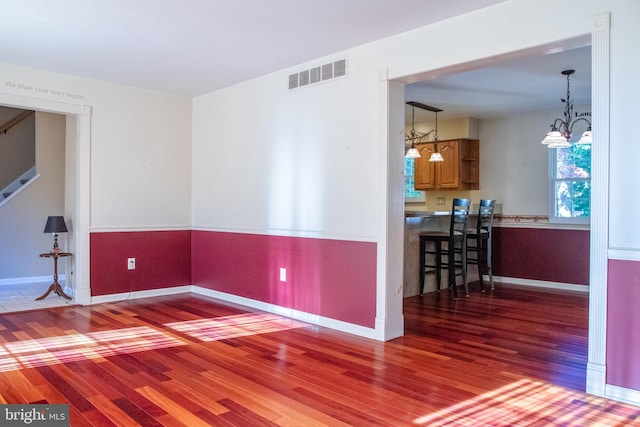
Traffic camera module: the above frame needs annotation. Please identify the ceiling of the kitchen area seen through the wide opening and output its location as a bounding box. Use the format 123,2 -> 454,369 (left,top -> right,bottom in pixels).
405,44 -> 591,121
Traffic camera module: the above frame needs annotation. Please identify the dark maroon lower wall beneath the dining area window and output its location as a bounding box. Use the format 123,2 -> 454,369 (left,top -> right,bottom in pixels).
493,227 -> 589,285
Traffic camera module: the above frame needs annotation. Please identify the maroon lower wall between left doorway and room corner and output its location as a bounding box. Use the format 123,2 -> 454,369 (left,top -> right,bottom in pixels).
90,230 -> 191,296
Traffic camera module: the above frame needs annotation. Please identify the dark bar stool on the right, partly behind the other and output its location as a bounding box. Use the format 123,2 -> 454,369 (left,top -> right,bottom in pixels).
467,199 -> 496,292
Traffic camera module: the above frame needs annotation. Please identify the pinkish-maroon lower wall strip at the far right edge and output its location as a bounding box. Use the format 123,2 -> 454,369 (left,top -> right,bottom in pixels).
607,260 -> 640,390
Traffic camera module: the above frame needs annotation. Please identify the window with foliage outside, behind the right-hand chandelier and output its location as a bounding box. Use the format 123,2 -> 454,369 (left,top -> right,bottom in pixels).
549,144 -> 591,224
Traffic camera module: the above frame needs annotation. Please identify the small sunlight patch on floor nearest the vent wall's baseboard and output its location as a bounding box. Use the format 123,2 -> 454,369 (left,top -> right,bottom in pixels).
165,313 -> 309,341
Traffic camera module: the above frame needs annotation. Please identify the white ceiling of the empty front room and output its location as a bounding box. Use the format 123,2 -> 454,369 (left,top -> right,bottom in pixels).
0,0 -> 505,96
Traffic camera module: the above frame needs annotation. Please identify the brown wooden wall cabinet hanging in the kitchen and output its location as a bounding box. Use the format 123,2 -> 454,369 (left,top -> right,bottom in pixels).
413,139 -> 480,191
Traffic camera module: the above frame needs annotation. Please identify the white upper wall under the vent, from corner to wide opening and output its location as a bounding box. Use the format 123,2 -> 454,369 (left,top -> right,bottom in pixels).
193,49 -> 379,240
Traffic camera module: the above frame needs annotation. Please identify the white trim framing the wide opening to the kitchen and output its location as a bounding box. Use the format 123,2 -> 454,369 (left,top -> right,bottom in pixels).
378,14 -> 610,396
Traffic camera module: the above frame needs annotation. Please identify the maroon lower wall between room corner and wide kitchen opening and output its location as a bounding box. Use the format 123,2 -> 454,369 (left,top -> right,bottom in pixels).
192,231 -> 377,327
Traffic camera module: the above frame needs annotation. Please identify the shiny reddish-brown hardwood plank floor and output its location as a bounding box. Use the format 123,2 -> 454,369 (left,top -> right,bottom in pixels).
0,285 -> 640,427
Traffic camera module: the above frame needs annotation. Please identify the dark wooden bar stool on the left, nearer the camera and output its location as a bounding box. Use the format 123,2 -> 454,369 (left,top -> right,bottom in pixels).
419,199 -> 471,299
